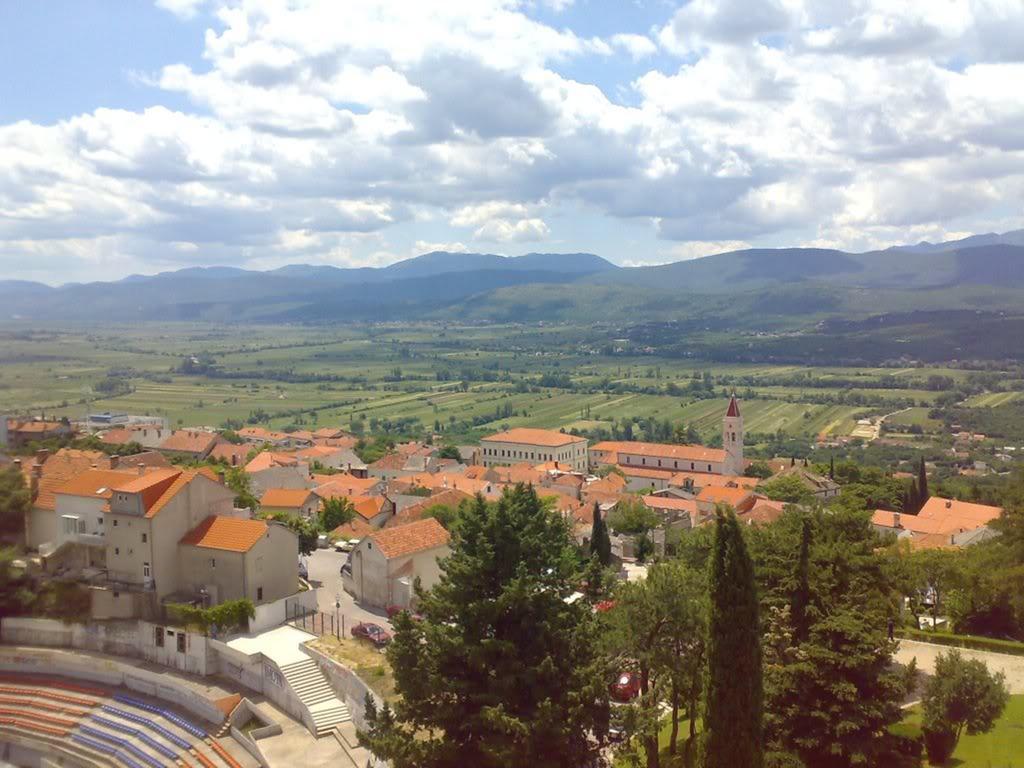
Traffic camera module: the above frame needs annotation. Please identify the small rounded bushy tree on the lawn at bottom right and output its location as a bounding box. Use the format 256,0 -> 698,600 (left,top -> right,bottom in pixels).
922,650 -> 1010,764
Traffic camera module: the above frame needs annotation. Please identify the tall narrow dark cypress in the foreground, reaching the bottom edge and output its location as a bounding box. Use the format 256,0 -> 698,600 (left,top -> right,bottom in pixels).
705,510 -> 764,768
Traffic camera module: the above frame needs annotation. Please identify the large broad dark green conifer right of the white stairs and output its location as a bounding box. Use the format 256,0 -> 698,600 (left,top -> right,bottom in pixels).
359,484 -> 607,768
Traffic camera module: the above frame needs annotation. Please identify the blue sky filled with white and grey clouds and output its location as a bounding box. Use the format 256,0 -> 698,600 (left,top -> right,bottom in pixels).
0,0 -> 1024,284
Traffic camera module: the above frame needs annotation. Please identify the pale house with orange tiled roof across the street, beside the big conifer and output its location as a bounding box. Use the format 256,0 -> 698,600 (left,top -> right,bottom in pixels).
341,517 -> 451,608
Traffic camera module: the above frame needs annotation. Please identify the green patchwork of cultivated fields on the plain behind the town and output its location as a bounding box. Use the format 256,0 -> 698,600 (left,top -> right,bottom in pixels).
0,325 -> 1018,448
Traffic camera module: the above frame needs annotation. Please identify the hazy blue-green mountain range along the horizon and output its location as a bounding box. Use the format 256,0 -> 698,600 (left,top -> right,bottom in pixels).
6,229 -> 1024,329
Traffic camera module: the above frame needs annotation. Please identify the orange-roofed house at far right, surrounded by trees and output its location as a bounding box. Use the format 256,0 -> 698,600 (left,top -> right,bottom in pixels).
871,496 -> 1002,548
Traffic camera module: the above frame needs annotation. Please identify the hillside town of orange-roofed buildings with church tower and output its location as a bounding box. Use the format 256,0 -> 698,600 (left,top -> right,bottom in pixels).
0,395 -> 1024,766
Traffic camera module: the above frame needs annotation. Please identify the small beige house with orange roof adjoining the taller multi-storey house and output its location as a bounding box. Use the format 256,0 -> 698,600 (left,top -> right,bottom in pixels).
177,515 -> 299,605
